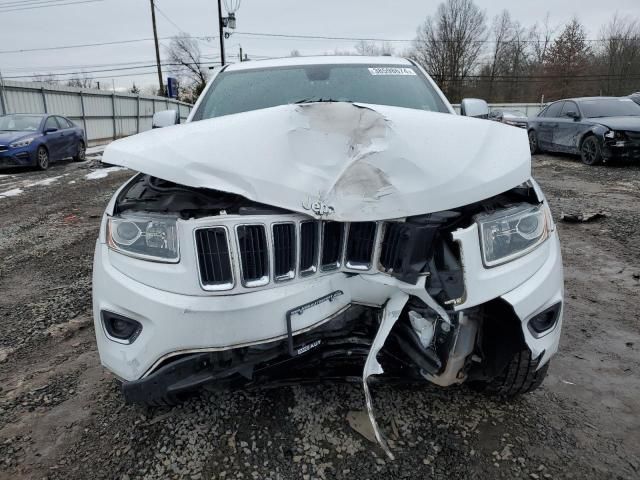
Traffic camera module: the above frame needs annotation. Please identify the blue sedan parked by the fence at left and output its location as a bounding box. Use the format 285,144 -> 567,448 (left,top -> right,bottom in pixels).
0,113 -> 87,170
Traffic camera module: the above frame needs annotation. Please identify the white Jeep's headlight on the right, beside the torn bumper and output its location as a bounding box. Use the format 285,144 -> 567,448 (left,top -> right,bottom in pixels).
476,203 -> 553,267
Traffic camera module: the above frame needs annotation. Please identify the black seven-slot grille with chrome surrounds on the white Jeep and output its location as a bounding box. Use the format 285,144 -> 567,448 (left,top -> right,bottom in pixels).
195,217 -> 382,291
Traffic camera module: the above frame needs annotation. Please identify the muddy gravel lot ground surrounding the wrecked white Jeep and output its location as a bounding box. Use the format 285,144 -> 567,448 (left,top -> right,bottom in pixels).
0,156 -> 640,479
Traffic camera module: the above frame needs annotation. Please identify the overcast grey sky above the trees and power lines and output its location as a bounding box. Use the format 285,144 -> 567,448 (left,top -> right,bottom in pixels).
0,0 -> 640,89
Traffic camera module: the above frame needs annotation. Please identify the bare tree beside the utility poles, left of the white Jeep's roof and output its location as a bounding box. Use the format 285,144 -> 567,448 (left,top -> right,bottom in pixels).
166,33 -> 207,102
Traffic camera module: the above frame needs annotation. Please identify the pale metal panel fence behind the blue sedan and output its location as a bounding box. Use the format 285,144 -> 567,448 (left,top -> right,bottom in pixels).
0,80 -> 191,145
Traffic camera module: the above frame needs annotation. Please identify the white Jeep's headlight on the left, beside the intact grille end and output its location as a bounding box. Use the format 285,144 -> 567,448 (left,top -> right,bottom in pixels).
107,215 -> 180,263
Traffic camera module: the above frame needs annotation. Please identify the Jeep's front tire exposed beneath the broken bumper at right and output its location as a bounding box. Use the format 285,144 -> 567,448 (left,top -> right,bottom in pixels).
475,349 -> 549,397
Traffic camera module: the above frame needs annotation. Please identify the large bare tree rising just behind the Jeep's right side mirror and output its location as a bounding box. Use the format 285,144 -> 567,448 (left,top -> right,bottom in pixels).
412,0 -> 487,100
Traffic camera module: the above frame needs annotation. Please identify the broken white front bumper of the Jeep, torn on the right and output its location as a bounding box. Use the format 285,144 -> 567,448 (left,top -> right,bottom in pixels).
93,229 -> 563,381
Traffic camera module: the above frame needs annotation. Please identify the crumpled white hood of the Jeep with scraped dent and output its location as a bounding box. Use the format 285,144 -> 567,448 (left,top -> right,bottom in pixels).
103,103 -> 531,221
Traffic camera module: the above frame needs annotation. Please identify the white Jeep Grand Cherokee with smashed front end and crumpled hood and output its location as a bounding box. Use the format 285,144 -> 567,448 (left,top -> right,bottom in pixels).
93,56 -> 563,458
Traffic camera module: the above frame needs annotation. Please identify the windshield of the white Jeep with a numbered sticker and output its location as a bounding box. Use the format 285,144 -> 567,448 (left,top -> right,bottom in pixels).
193,65 -> 449,120
